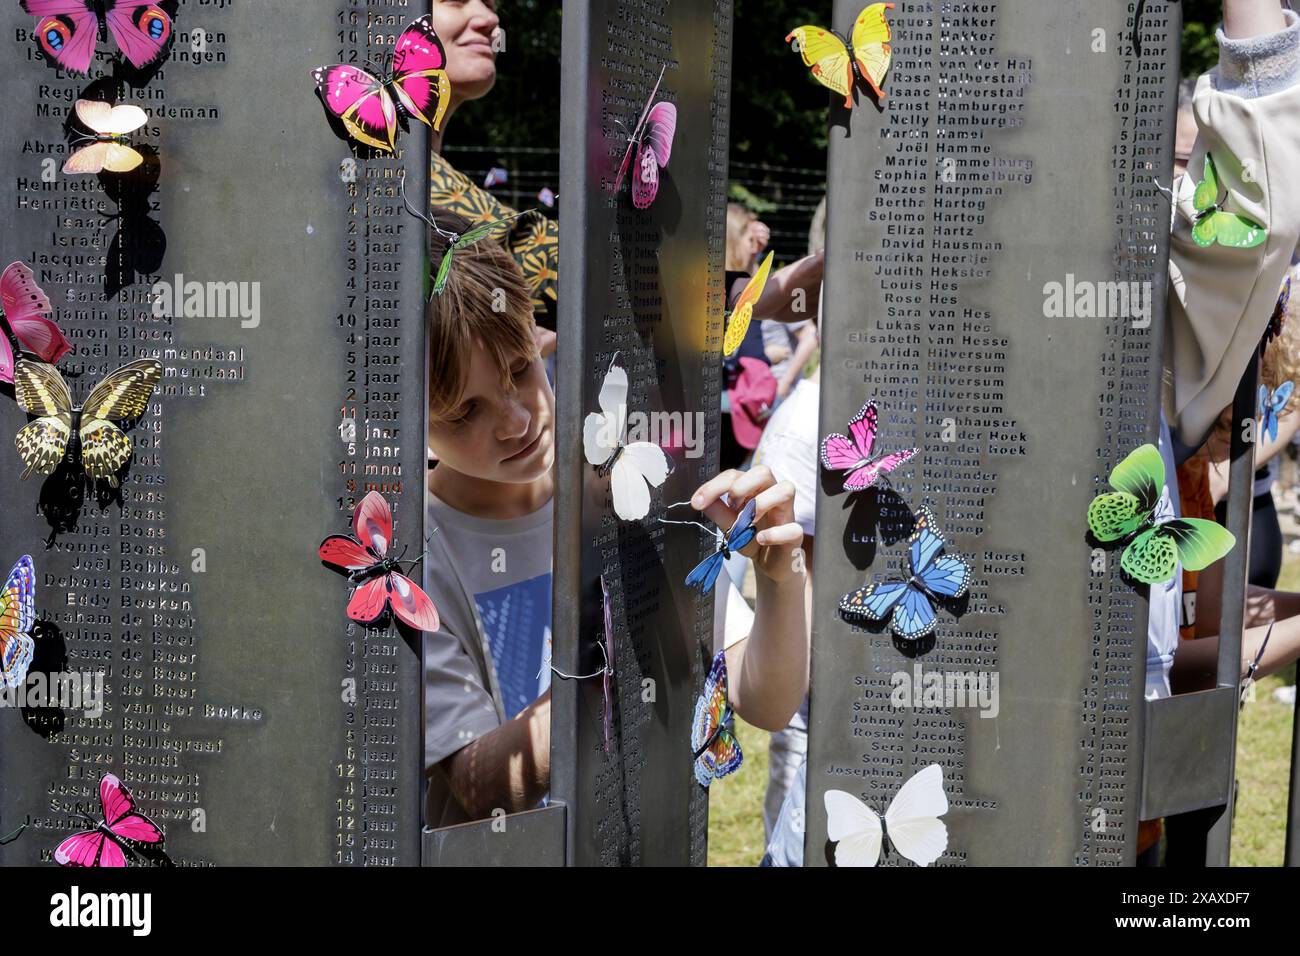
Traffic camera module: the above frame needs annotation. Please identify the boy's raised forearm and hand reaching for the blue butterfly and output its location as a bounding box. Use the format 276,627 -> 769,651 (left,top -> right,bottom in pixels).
690,464 -> 809,731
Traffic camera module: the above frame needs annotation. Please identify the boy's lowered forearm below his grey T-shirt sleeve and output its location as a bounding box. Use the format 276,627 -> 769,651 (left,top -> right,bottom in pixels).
442,691 -> 551,819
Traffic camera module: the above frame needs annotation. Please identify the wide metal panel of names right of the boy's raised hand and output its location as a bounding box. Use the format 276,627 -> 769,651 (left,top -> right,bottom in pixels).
806,0 -> 1180,865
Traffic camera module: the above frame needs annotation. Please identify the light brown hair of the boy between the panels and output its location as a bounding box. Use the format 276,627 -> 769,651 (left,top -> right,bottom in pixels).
426,209 -> 537,421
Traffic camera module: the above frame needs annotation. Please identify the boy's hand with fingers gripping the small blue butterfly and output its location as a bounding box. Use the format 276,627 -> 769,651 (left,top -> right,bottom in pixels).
690,464 -> 803,587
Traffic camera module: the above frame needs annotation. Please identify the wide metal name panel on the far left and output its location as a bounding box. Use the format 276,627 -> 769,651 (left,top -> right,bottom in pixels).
0,0 -> 428,866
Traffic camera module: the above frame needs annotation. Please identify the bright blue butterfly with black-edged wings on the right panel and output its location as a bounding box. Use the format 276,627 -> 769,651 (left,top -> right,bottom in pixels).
840,507 -> 971,641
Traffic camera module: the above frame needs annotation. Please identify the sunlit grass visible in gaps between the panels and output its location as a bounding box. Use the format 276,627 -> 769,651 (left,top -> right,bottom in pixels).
709,554 -> 1300,866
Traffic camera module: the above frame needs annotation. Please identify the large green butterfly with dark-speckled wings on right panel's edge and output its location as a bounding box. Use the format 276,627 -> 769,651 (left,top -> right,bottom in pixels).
1088,445 -> 1236,584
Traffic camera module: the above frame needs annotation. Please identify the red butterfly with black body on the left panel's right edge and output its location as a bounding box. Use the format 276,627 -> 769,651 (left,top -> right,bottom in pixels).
320,492 -> 438,631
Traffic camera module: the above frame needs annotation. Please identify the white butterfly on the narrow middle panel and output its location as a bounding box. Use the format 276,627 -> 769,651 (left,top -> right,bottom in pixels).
582,364 -> 668,522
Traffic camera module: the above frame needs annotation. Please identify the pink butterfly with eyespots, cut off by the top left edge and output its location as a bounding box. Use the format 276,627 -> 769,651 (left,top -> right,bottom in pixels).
22,0 -> 172,73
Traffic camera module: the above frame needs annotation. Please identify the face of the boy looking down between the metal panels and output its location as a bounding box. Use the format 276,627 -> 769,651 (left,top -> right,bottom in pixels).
429,342 -> 555,484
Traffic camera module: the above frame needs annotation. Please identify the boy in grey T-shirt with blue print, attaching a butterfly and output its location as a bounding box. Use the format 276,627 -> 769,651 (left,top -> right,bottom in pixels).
424,218 -> 809,827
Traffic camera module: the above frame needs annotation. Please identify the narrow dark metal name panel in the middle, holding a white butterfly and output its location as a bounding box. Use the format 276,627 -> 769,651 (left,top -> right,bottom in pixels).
551,0 -> 732,865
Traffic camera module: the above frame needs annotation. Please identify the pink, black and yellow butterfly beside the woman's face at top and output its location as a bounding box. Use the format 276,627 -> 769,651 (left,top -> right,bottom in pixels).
312,13 -> 451,152
